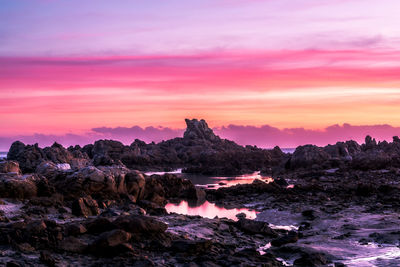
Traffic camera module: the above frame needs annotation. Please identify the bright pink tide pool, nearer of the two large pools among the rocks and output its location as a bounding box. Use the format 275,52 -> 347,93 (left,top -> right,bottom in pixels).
165,201 -> 257,221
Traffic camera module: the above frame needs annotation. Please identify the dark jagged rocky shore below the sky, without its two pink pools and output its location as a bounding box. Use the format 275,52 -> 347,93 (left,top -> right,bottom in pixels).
0,120 -> 400,266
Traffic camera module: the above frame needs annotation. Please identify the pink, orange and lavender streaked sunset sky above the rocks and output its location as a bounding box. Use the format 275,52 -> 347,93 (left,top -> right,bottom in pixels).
0,0 -> 400,150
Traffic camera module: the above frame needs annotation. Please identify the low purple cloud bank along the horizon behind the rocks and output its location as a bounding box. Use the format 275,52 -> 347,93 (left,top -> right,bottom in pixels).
0,123 -> 400,151
